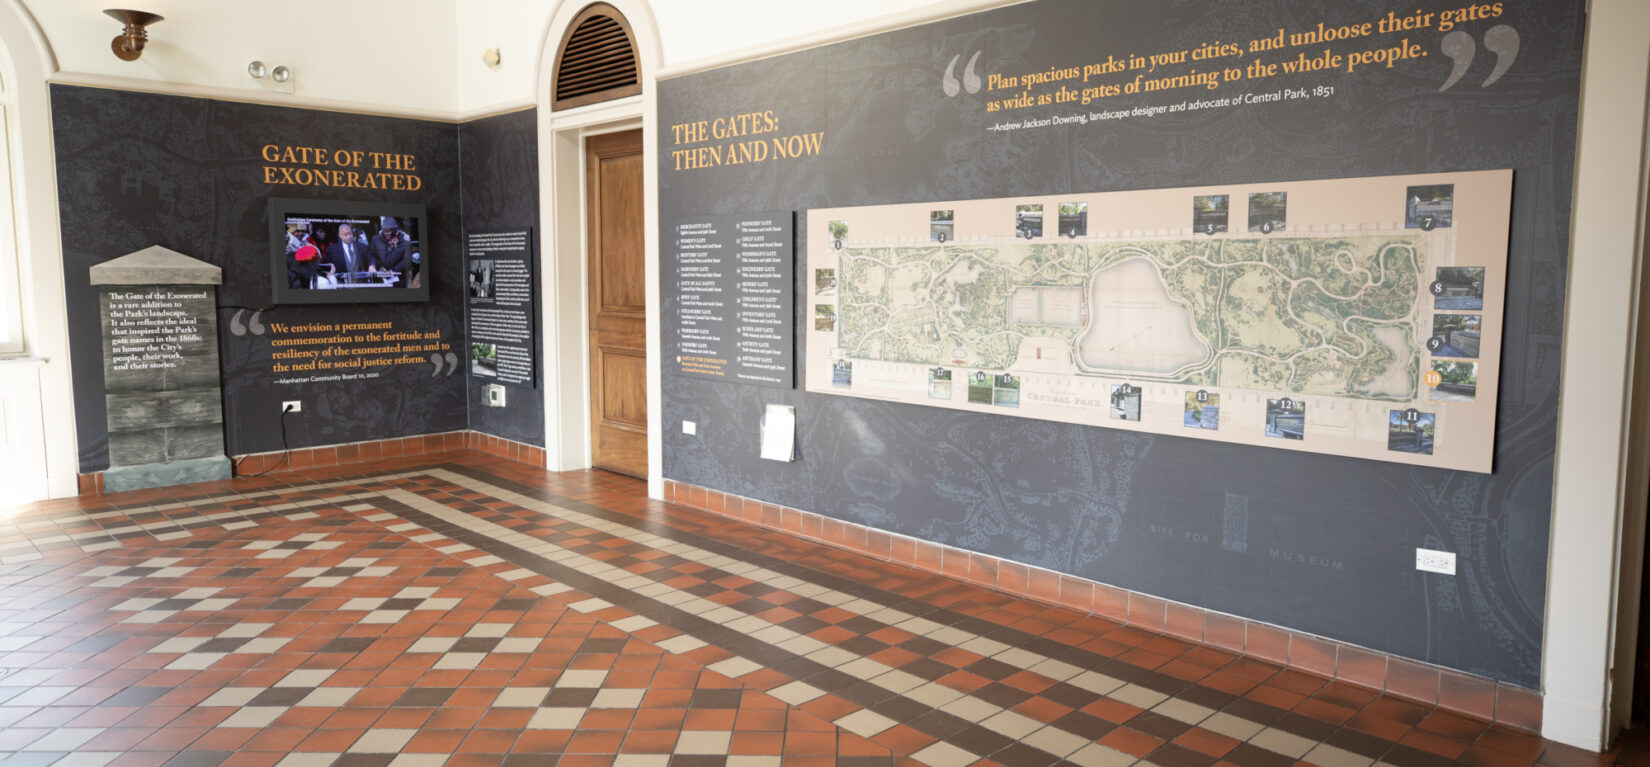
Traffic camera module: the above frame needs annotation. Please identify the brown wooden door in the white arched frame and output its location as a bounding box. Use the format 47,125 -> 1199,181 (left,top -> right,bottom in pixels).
584,130 -> 647,477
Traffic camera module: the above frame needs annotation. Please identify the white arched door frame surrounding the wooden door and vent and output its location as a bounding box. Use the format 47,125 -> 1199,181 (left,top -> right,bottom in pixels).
535,0 -> 665,498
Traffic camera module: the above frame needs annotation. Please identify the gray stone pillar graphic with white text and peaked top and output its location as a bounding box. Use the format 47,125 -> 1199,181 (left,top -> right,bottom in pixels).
91,246 -> 231,492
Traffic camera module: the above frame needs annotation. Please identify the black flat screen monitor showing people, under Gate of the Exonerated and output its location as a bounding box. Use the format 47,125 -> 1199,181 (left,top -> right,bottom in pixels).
269,198 -> 434,304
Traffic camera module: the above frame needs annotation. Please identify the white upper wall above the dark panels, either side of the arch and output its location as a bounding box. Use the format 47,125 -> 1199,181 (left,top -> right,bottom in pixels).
20,0 -> 963,119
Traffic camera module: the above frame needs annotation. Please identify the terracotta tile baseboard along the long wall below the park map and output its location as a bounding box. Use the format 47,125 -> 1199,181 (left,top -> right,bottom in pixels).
665,480 -> 1543,734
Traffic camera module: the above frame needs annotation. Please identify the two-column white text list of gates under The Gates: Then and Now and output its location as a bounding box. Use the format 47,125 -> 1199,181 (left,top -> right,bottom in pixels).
672,211 -> 795,388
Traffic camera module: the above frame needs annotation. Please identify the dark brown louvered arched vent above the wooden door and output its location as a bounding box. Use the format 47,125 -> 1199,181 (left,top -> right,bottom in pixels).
551,3 -> 642,109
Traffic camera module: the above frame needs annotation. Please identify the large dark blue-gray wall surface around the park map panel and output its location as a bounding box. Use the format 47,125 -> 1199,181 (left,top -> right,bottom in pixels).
658,0 -> 1582,686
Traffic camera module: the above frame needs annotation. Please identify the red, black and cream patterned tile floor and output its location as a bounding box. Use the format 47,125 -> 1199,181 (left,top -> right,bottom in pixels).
0,452 -> 1650,767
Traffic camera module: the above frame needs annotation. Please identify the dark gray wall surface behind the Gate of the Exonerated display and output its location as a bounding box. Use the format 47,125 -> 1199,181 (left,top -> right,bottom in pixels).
51,86 -> 467,472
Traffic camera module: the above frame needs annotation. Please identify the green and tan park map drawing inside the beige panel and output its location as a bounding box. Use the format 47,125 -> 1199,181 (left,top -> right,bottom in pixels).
837,231 -> 1436,401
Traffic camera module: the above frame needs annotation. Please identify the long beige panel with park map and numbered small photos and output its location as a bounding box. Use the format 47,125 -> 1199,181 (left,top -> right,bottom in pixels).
807,170 -> 1511,472
